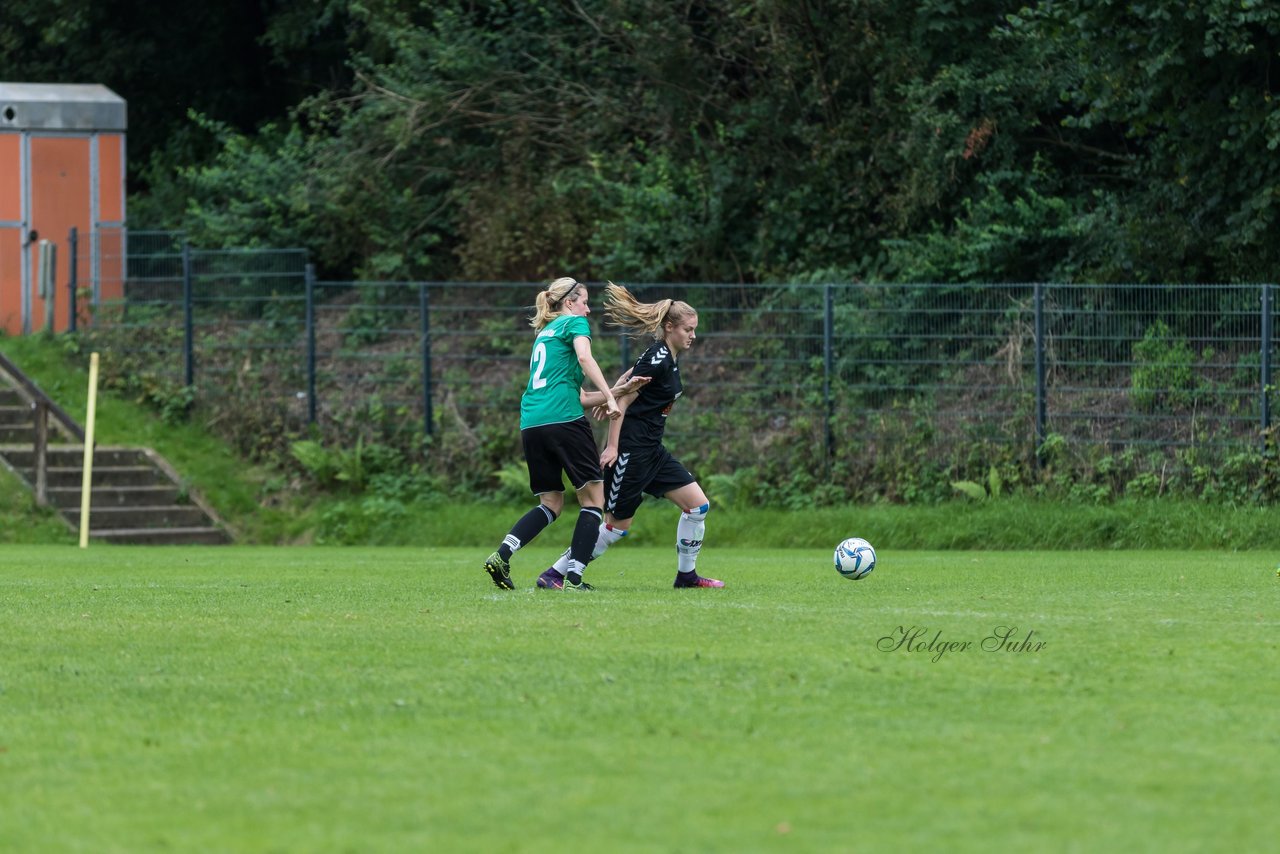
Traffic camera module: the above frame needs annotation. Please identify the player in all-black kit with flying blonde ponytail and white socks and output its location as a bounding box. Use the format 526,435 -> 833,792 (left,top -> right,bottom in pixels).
538,282 -> 724,588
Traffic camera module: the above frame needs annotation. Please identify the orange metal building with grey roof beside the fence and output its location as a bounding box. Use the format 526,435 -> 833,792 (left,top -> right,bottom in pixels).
0,83 -> 127,334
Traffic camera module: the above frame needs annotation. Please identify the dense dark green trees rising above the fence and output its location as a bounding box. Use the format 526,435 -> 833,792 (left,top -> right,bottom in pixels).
0,0 -> 1280,282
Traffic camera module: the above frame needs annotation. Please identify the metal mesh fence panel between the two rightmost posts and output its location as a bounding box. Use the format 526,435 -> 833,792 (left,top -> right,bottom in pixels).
1044,284 -> 1274,448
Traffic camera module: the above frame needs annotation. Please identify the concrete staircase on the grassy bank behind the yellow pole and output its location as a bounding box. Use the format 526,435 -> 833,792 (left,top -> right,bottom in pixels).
0,356 -> 232,544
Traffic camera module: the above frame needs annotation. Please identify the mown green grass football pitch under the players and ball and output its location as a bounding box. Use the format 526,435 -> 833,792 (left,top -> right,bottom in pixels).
0,545 -> 1280,854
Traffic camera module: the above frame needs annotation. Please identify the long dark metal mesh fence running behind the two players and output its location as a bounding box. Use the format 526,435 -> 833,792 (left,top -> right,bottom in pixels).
62,233 -> 1275,486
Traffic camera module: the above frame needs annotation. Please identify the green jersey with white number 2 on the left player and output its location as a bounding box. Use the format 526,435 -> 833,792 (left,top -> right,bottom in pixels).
520,315 -> 591,430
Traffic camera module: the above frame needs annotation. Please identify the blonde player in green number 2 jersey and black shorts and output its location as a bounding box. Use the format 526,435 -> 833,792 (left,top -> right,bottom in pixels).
484,277 -> 622,590
